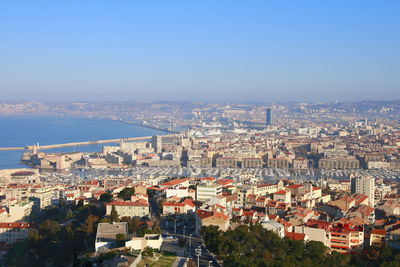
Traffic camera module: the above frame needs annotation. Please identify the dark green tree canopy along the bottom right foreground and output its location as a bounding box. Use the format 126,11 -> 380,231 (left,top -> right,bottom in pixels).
202,224 -> 400,267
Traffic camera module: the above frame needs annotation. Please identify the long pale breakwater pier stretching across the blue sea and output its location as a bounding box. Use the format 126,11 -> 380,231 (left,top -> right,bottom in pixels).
0,134 -> 175,151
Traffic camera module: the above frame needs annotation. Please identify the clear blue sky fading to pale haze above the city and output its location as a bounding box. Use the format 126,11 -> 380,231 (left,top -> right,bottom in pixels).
0,0 -> 400,102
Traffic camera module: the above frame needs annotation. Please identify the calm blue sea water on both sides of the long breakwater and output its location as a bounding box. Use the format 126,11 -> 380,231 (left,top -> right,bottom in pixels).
0,115 -> 166,169
